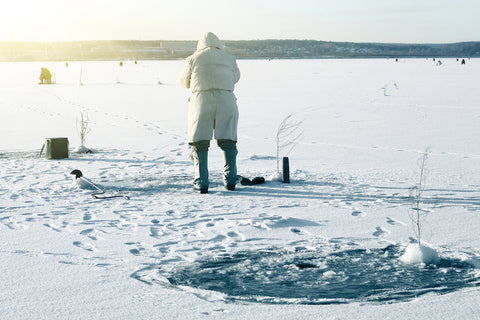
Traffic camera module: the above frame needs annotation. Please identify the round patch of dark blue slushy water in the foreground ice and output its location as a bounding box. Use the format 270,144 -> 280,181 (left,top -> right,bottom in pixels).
168,246 -> 480,304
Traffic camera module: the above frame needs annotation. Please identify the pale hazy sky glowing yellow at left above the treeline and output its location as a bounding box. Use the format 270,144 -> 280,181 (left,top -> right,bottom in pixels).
0,0 -> 480,43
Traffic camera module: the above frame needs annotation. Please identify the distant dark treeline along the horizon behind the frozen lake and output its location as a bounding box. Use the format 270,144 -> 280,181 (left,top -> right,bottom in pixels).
0,40 -> 480,61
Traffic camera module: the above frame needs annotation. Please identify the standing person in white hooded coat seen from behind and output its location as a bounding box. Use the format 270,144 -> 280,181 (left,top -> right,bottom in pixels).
180,32 -> 240,193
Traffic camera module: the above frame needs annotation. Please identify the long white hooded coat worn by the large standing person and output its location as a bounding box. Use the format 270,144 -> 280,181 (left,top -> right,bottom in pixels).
180,32 -> 240,143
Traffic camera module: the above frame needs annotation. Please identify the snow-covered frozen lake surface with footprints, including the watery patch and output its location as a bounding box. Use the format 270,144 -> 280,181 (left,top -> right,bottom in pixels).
0,59 -> 480,319
